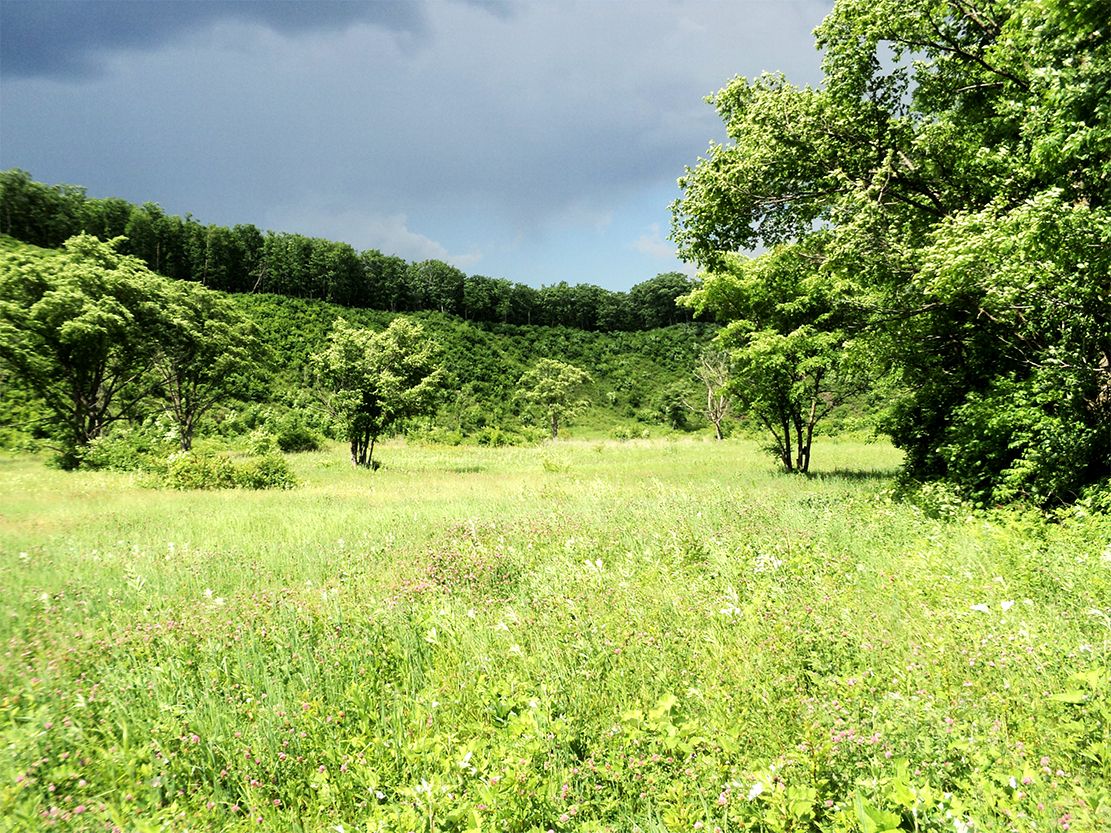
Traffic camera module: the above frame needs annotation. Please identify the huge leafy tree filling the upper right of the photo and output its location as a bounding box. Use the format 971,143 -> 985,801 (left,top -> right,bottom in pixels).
673,0 -> 1111,503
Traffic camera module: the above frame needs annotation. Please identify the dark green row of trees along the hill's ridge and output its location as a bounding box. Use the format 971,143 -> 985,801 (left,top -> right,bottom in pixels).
0,169 -> 691,331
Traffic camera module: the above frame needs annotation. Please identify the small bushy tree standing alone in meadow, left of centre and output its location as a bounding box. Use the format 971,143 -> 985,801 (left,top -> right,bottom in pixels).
313,318 -> 446,469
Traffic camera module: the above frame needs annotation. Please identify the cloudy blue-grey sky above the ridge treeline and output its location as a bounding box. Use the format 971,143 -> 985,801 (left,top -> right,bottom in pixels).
0,0 -> 832,290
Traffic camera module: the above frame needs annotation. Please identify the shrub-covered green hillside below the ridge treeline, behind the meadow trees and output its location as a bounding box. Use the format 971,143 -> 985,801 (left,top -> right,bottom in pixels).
0,238 -> 714,444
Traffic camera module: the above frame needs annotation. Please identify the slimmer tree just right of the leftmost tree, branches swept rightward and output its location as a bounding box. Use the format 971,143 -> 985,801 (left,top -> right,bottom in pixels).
152,281 -> 264,451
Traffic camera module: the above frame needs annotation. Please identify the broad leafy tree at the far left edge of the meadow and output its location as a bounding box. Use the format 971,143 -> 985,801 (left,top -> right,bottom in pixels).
0,234 -> 162,468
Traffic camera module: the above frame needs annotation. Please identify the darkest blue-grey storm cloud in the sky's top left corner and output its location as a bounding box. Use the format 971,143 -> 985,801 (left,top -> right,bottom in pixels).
0,0 -> 428,78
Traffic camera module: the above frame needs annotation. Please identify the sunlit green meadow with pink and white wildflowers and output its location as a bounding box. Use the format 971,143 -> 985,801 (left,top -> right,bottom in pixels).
0,440 -> 1111,833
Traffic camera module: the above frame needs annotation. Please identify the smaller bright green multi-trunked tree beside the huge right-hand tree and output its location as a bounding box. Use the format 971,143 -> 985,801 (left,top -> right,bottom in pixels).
684,244 -> 867,473
